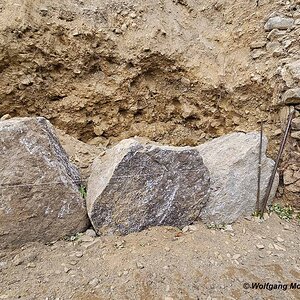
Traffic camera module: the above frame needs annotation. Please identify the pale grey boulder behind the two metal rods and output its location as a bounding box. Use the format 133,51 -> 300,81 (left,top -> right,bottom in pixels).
197,132 -> 278,224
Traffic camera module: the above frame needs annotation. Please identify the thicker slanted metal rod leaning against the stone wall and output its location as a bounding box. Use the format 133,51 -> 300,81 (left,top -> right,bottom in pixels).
261,110 -> 294,217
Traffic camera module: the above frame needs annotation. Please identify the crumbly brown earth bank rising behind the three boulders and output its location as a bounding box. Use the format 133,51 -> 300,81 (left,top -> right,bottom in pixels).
0,0 -> 286,149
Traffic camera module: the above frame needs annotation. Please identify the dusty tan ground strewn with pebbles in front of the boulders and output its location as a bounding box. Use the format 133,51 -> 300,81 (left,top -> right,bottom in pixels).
0,214 -> 300,300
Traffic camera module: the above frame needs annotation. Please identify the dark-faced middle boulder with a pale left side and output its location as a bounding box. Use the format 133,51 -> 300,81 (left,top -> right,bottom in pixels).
87,139 -> 209,234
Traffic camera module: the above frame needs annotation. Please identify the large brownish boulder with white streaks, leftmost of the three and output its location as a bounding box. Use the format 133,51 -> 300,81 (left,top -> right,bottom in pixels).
0,118 -> 89,248
